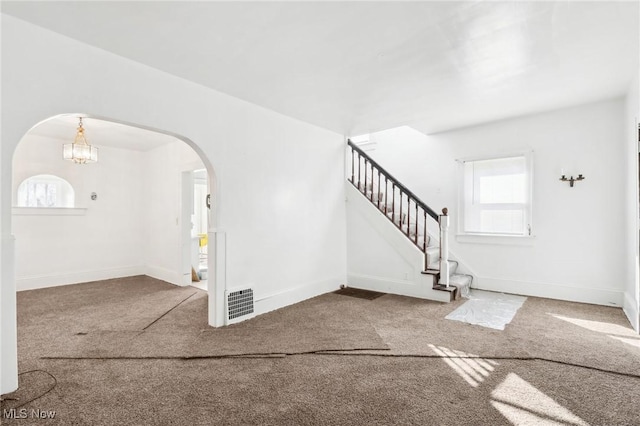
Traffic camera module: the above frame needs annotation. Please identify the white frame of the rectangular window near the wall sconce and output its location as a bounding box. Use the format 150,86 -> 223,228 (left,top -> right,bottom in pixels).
456,150 -> 535,244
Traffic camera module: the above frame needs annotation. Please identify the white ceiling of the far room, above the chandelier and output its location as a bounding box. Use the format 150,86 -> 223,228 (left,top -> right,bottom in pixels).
29,114 -> 178,151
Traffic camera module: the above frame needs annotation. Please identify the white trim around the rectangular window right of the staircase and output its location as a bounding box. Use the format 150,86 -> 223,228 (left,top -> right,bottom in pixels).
456,150 -> 535,245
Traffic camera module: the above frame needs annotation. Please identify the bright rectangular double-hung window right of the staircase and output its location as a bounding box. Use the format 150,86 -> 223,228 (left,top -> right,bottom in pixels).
461,155 -> 531,236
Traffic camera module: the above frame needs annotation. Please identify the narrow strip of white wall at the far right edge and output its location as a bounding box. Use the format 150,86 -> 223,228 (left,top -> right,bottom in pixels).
623,77 -> 640,331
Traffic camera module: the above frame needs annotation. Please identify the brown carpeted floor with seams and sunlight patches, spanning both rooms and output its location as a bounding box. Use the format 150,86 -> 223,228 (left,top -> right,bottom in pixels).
1,277 -> 640,425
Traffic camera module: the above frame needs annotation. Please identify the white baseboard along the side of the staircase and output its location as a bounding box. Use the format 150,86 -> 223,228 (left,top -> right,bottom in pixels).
347,273 -> 451,302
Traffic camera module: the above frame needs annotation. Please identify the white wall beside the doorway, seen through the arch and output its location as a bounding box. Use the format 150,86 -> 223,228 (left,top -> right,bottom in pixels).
141,141 -> 204,284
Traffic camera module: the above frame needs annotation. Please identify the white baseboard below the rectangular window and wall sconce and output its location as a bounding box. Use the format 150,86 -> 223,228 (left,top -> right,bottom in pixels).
472,276 -> 623,307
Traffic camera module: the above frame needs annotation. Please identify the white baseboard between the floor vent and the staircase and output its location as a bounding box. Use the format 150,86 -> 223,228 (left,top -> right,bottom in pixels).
255,277 -> 345,315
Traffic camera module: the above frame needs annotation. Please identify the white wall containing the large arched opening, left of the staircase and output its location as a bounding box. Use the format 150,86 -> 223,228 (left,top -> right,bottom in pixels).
0,15 -> 346,393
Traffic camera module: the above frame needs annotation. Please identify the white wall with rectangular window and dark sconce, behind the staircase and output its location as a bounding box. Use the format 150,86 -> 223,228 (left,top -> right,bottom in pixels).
372,99 -> 627,306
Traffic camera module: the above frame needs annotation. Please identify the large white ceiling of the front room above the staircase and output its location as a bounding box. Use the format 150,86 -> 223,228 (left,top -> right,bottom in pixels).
2,0 -> 639,135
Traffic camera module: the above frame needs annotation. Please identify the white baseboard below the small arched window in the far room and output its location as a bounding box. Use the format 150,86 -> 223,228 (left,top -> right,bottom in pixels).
16,266 -> 145,291
